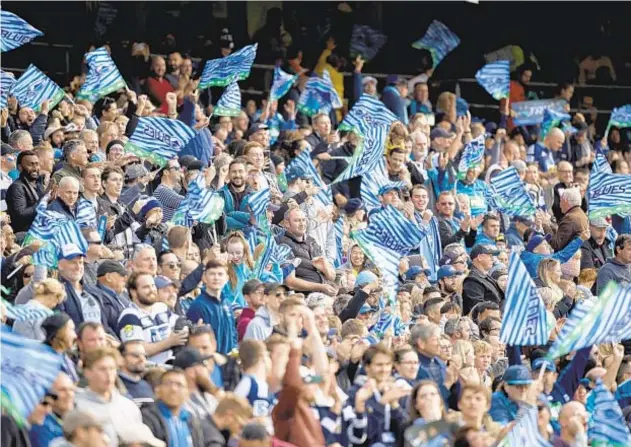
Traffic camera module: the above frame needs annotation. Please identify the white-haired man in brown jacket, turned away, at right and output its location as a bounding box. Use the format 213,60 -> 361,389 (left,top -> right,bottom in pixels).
550,188 -> 590,251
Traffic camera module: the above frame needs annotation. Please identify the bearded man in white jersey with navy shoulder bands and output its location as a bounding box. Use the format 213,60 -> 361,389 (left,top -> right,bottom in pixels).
118,272 -> 188,364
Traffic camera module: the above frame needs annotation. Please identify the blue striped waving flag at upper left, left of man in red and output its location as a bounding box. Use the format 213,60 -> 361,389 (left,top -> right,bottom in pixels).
77,47 -> 127,102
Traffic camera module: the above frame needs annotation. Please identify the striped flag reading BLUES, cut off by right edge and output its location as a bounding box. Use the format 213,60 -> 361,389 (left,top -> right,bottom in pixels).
587,172 -> 631,219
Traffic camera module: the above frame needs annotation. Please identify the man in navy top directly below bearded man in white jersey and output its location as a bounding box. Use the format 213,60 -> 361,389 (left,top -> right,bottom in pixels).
118,340 -> 153,407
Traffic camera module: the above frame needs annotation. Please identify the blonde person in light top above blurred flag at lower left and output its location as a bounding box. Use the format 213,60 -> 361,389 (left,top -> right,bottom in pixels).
13,278 -> 66,341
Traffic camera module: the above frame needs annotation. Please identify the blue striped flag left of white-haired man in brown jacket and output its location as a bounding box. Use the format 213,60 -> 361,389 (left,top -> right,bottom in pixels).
485,166 -> 537,217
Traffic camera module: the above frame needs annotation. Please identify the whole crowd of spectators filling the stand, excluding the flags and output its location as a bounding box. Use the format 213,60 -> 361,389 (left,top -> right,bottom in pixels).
0,8 -> 631,447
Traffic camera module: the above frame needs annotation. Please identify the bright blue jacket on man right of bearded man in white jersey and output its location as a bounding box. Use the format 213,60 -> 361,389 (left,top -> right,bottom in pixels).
186,290 -> 237,355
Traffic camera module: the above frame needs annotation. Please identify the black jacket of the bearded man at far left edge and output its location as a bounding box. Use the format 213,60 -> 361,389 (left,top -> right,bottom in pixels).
6,174 -> 44,233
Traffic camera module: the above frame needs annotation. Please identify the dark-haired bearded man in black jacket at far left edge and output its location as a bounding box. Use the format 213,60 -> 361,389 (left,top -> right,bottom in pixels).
6,151 -> 44,233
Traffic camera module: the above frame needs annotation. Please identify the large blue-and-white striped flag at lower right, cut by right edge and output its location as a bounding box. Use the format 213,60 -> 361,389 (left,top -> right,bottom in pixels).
547,282 -> 631,359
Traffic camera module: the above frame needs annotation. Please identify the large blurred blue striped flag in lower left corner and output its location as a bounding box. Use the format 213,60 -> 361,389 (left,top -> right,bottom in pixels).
0,325 -> 63,423
